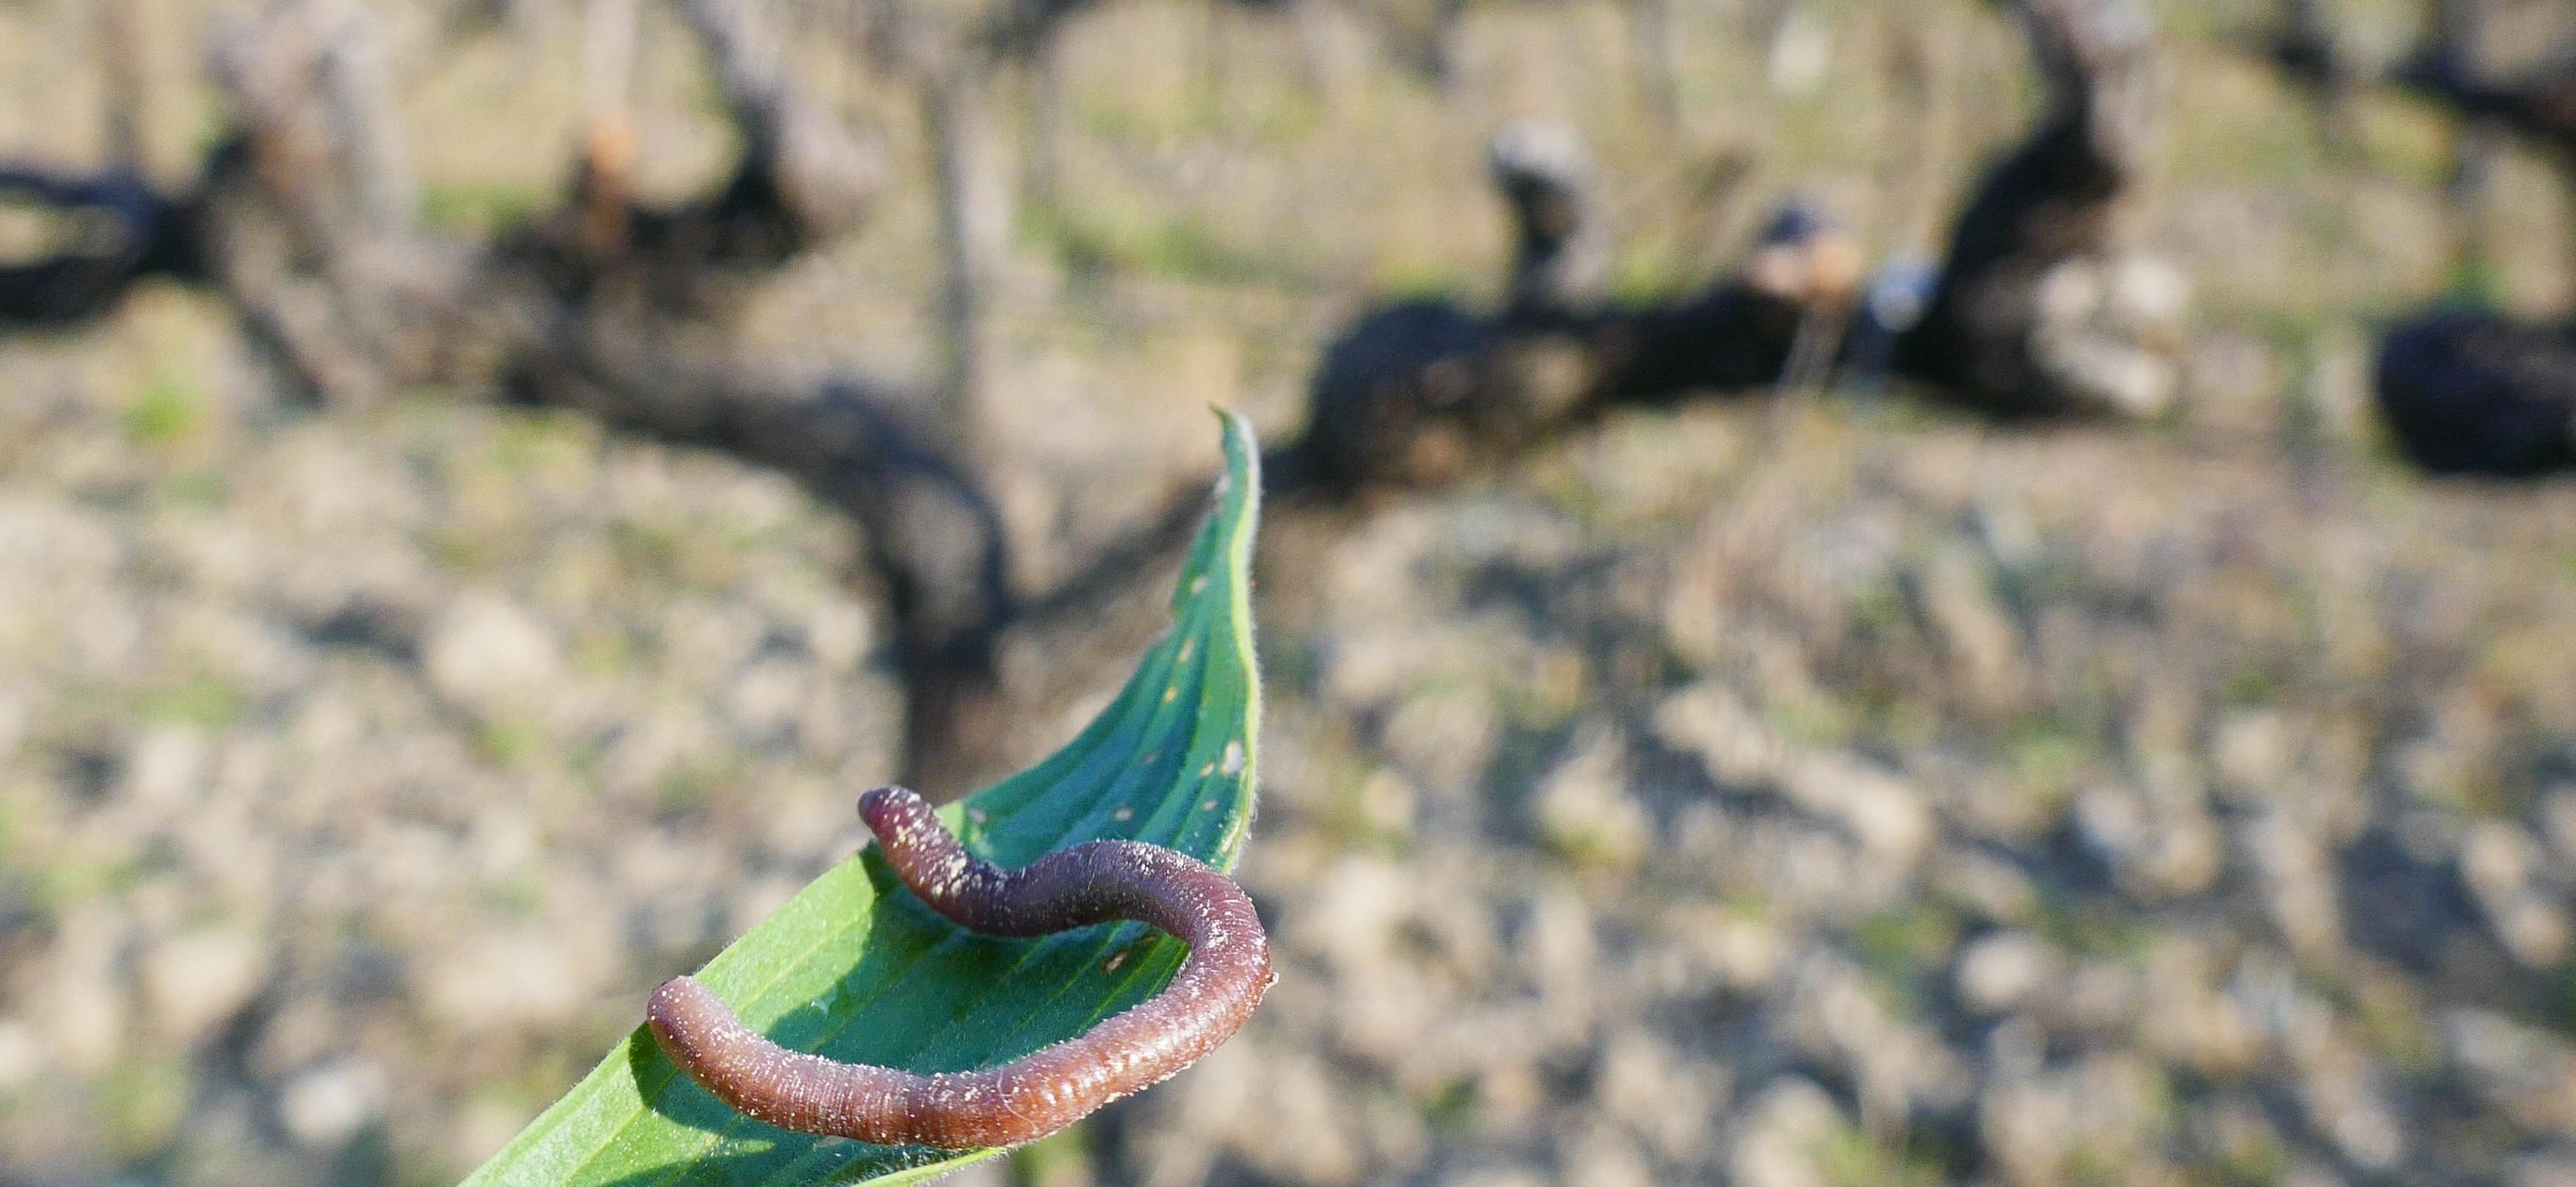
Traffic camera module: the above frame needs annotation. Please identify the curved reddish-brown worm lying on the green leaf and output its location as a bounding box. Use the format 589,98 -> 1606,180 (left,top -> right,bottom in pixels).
644,788 -> 1273,1151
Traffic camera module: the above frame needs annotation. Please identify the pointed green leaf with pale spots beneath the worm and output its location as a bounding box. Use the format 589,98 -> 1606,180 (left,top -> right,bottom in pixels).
466,412 -> 1259,1187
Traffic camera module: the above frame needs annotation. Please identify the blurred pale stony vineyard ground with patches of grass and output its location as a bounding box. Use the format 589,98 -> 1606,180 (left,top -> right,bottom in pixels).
0,5 -> 2576,1187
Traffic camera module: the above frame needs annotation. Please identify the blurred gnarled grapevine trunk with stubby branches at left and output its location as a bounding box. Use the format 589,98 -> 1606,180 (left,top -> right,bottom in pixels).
0,0 -> 1076,793
